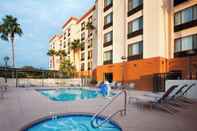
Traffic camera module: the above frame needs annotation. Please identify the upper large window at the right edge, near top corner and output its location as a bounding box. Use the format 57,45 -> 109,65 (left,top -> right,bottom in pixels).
174,5 -> 197,26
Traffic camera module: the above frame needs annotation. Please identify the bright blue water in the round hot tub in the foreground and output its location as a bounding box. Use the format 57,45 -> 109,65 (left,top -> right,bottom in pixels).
23,114 -> 122,131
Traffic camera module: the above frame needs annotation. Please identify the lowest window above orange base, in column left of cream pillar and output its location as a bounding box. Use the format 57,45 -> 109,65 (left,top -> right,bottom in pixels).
128,42 -> 143,57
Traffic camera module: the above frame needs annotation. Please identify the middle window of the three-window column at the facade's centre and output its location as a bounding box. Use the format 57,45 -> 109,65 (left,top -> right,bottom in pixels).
128,17 -> 143,34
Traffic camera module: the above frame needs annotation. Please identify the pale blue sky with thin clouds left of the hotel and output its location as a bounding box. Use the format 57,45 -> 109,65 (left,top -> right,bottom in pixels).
0,0 -> 95,69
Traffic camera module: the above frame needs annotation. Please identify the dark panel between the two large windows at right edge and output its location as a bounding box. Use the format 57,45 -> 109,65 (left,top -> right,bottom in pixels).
174,20 -> 197,32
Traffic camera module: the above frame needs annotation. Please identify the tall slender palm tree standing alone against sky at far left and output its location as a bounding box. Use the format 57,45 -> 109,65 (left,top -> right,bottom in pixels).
0,15 -> 23,67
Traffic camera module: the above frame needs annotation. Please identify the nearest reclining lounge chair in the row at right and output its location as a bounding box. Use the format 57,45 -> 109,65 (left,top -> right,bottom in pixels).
129,85 -> 178,113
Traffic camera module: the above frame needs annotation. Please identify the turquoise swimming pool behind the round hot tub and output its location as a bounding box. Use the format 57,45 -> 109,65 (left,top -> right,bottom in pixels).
36,88 -> 115,101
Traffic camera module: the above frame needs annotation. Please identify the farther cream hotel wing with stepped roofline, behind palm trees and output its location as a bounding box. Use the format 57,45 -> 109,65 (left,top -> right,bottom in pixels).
49,6 -> 96,76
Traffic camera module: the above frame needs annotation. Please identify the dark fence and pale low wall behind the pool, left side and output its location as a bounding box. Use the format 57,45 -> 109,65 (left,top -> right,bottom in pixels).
0,67 -> 81,87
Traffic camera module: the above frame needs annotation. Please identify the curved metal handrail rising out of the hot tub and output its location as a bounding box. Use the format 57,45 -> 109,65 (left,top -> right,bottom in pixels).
91,90 -> 127,128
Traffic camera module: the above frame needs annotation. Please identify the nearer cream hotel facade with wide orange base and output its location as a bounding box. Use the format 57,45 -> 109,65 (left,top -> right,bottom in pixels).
49,0 -> 197,90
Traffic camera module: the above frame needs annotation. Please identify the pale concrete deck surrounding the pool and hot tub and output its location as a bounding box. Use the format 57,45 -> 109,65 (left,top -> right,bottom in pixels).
0,88 -> 197,131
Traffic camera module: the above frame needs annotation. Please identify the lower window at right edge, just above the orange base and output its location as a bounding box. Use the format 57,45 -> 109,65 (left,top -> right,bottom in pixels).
174,35 -> 197,53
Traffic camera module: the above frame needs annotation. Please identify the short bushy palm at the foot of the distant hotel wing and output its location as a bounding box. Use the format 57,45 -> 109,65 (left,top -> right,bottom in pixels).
60,60 -> 76,77
